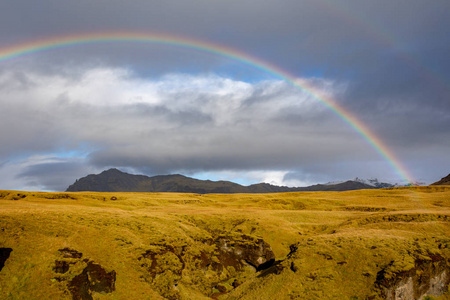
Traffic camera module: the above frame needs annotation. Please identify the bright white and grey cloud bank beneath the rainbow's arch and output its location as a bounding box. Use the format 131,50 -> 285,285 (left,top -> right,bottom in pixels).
0,68 -> 394,187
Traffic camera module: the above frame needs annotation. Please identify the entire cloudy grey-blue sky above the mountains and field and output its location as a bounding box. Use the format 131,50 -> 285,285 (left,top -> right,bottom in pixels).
0,0 -> 450,191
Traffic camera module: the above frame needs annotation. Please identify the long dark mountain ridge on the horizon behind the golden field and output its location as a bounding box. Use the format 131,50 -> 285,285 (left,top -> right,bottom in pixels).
66,169 -> 384,194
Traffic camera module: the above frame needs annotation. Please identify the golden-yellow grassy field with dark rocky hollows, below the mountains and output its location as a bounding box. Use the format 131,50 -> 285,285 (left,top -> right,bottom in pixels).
0,186 -> 450,299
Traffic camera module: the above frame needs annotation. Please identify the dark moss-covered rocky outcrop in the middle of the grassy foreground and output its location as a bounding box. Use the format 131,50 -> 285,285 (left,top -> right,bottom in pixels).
138,235 -> 275,299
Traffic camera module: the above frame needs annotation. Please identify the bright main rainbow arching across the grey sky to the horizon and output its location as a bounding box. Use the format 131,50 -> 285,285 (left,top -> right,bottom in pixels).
0,32 -> 413,183
